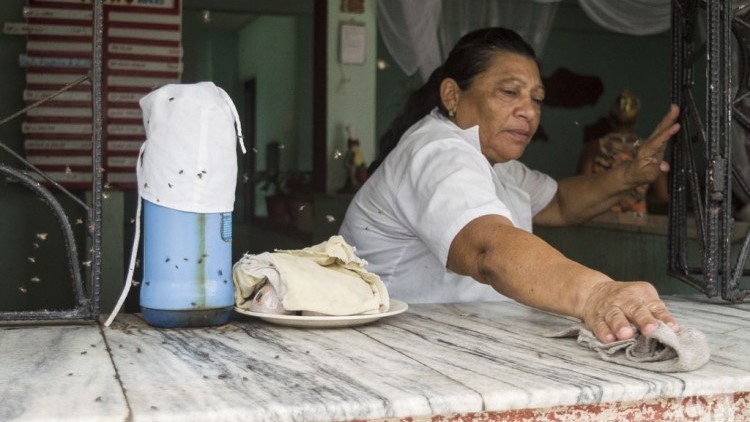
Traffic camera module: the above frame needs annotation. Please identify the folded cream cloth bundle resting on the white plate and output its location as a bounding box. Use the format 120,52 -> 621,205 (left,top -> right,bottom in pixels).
232,236 -> 389,315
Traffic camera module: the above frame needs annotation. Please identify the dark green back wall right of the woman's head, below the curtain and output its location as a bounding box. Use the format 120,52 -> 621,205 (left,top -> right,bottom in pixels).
522,0 -> 672,178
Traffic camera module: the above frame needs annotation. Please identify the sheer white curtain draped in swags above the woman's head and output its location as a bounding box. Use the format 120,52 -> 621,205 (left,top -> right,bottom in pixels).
378,0 -> 671,80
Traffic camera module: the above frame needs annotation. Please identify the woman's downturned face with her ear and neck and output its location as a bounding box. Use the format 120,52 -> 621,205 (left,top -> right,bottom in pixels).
448,52 -> 544,164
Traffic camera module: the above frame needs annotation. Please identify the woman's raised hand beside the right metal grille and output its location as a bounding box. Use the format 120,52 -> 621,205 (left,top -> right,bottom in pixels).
625,104 -> 680,186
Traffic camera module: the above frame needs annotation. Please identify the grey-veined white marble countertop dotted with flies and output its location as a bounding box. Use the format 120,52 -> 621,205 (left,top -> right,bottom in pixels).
0,296 -> 750,421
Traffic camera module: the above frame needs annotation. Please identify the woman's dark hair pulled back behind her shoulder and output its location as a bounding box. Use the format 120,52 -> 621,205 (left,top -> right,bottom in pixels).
367,27 -> 536,174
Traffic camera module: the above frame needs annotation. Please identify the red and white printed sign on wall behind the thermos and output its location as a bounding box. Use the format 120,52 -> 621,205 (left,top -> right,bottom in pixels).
15,0 -> 182,189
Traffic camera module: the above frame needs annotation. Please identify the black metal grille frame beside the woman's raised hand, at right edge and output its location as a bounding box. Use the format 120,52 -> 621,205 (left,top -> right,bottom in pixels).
668,0 -> 750,302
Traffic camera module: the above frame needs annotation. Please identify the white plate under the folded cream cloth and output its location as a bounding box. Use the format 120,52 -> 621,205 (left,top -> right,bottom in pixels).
234,299 -> 409,328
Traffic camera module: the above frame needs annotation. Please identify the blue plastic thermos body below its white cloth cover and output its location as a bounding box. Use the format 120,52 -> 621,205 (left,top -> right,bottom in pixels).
141,200 -> 234,328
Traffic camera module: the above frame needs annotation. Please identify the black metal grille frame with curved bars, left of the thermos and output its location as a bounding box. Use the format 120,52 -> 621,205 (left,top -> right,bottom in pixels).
0,0 -> 103,322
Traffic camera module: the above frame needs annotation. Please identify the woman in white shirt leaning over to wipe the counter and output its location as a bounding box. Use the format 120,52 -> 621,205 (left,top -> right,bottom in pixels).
340,28 -> 679,342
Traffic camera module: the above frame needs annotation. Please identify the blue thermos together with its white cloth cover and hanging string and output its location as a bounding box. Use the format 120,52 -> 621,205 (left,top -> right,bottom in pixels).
105,82 -> 245,327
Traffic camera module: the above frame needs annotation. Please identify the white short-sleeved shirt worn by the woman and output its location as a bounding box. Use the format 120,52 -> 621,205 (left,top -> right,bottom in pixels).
339,110 -> 557,303
